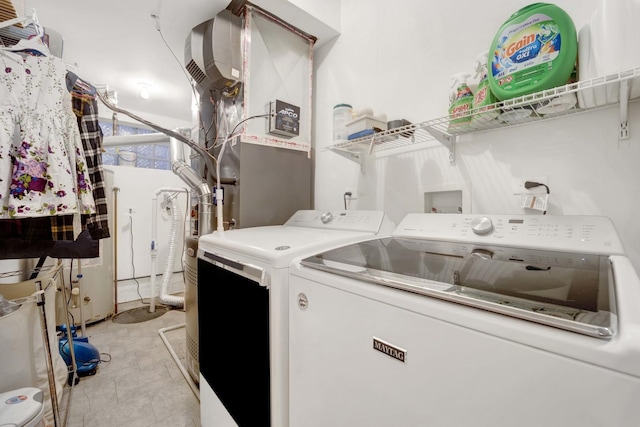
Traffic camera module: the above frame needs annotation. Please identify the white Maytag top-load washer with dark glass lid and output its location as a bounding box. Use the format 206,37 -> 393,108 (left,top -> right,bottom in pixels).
289,214 -> 640,427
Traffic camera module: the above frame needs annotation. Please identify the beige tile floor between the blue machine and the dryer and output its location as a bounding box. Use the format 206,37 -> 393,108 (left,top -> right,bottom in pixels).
60,302 -> 200,427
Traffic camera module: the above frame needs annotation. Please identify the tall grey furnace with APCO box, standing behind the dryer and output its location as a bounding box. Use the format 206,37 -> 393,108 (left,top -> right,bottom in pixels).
182,5 -> 315,392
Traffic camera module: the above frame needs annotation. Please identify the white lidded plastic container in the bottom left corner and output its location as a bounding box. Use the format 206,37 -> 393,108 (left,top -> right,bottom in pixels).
0,387 -> 45,427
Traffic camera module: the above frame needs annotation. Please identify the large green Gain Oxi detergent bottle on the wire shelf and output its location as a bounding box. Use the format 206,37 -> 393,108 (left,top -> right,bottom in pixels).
488,3 -> 578,101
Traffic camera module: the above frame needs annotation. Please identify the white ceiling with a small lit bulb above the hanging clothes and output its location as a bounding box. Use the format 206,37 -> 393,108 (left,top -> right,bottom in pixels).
24,0 -> 229,127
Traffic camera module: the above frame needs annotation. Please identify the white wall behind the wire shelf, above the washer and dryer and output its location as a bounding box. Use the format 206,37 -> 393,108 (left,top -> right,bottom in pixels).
314,0 -> 640,270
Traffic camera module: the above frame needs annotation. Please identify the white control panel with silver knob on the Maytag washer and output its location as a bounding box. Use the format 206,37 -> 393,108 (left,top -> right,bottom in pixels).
392,213 -> 625,255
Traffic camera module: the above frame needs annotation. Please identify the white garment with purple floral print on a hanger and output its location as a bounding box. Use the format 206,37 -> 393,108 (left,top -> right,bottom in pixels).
0,50 -> 95,219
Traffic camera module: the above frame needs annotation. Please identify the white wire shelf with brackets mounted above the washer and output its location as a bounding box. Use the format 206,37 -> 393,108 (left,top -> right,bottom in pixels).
329,67 -> 640,162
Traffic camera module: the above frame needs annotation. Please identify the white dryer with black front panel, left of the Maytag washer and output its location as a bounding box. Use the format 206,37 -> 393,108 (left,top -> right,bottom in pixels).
197,210 -> 394,427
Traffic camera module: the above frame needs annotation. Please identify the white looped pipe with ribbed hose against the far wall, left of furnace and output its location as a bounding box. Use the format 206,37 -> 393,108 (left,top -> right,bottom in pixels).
149,188 -> 189,313
